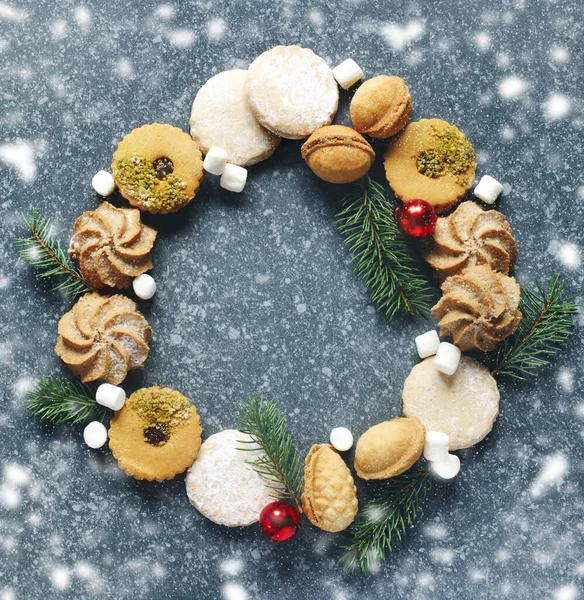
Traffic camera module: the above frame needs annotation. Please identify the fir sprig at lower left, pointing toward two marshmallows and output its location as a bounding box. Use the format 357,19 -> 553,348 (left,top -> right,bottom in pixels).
26,377 -> 109,424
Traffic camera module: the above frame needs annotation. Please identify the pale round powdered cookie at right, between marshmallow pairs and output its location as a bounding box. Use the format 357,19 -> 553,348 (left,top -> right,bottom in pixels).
402,356 -> 499,450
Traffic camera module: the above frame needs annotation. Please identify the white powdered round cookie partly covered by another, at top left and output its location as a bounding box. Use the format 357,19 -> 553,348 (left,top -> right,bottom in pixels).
191,69 -> 280,167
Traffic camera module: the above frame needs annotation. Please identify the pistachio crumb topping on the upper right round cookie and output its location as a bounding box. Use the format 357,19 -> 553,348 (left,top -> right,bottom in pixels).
417,125 -> 476,183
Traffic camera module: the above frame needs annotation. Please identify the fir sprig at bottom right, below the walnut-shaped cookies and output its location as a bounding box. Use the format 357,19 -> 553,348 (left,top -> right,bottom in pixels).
340,466 -> 432,575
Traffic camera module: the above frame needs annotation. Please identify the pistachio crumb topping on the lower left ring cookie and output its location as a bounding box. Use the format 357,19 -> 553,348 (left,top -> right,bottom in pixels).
132,387 -> 191,446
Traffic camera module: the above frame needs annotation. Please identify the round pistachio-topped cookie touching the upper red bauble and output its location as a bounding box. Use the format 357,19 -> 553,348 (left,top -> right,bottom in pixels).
384,119 -> 476,212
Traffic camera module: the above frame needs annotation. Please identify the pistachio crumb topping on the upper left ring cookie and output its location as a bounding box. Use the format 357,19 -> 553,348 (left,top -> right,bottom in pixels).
113,154 -> 189,210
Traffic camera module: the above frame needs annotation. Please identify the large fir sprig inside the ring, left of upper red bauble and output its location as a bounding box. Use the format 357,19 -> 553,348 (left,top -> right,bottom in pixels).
337,178 -> 432,321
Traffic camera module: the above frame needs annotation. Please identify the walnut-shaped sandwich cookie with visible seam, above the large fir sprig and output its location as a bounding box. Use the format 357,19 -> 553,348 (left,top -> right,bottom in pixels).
302,125 -> 375,183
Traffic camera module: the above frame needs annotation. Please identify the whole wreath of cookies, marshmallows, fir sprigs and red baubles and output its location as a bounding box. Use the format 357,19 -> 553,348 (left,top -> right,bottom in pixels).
15,46 -> 578,573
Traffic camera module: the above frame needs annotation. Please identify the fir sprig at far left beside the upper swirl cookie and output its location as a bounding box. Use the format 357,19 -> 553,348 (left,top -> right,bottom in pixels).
13,208 -> 94,297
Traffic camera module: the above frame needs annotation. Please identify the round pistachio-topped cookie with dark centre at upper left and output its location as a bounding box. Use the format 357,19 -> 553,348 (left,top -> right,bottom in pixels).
112,123 -> 203,213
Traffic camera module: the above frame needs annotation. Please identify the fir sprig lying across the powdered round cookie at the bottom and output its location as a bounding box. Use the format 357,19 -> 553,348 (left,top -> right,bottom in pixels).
235,394 -> 304,512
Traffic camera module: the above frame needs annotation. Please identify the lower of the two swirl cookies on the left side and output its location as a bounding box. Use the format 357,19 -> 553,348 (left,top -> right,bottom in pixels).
55,292 -> 152,385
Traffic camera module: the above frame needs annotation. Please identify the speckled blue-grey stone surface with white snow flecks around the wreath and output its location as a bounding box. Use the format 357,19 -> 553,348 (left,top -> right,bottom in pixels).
0,0 -> 584,600
